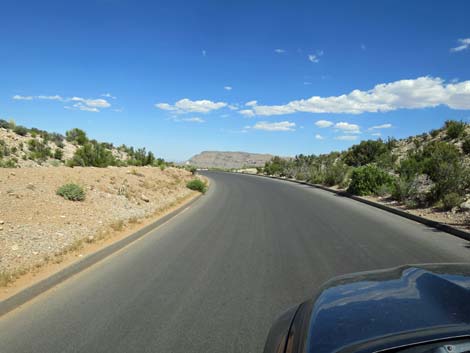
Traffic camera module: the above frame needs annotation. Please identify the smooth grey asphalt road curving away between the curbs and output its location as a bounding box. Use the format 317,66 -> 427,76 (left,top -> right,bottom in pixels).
0,173 -> 470,353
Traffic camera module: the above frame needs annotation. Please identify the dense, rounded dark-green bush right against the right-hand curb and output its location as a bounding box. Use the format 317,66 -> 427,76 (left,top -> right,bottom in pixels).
348,164 -> 393,196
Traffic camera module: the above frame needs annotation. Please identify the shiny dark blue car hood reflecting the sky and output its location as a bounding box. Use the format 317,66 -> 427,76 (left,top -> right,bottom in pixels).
306,264 -> 470,353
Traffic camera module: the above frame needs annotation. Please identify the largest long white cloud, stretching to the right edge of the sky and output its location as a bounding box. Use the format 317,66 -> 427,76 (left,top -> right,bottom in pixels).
239,76 -> 470,116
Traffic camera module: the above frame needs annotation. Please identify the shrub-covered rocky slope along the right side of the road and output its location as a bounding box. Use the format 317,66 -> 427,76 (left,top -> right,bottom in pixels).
258,120 -> 470,211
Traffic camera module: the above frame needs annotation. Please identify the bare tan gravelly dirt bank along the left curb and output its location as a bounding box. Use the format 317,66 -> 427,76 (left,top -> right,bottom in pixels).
0,167 -> 196,282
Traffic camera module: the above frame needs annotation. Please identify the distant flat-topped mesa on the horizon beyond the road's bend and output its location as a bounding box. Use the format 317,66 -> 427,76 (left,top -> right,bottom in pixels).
188,151 -> 273,169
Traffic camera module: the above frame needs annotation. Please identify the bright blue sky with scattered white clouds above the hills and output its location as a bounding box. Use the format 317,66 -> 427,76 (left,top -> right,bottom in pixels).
0,0 -> 470,160
